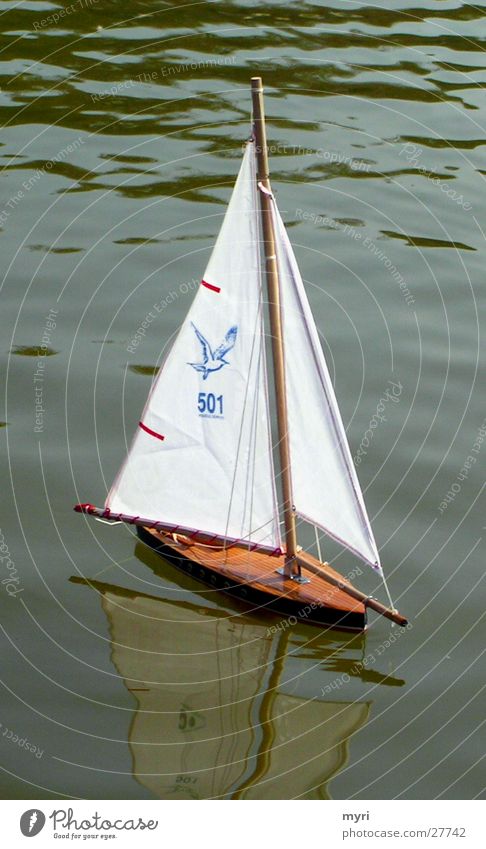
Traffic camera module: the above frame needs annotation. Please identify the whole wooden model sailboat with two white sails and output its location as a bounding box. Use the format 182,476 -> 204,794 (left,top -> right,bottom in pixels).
75,77 -> 406,630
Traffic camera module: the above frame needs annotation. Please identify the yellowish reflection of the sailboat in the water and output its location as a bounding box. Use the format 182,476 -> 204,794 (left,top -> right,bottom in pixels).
71,546 -> 402,799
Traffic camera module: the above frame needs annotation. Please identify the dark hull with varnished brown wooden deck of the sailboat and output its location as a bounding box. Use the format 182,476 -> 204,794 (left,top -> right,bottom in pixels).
137,526 -> 366,631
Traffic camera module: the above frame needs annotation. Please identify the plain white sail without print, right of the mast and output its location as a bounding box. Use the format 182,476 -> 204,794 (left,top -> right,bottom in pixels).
272,202 -> 381,574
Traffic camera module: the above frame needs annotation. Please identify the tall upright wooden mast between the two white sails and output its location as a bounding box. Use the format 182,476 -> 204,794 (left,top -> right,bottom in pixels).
251,77 -> 300,577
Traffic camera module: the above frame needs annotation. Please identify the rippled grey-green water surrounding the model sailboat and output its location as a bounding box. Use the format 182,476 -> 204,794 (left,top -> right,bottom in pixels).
0,0 -> 486,799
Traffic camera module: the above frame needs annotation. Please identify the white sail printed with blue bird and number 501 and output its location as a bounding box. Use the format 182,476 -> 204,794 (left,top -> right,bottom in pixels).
106,143 -> 280,549
